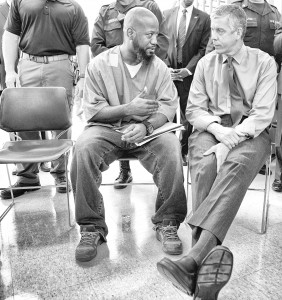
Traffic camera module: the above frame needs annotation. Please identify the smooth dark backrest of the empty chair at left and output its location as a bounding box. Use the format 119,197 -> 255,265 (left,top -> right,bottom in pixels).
0,87 -> 72,132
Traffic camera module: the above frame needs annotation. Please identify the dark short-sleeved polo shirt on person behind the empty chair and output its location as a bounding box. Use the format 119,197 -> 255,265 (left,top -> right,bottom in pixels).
6,0 -> 89,56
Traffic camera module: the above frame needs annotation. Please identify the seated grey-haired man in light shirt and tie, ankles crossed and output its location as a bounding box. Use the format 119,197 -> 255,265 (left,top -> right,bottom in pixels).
157,5 -> 277,300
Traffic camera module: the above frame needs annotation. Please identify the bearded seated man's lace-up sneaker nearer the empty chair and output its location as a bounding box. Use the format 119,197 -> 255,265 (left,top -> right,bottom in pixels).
75,225 -> 100,262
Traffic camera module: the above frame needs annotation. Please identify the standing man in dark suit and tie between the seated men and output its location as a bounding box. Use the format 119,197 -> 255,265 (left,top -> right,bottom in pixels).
164,0 -> 210,165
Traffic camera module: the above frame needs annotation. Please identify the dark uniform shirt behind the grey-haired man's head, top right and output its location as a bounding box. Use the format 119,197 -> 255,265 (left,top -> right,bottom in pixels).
232,0 -> 281,56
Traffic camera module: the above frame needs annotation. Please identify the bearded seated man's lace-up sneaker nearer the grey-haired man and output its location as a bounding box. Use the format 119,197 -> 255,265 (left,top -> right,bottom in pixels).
155,219 -> 183,255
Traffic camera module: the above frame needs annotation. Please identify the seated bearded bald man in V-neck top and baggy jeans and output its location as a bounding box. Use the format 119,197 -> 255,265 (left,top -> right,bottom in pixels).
71,7 -> 187,261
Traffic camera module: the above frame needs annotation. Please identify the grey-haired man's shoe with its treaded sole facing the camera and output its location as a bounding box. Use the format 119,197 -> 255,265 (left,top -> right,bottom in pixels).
194,246 -> 233,300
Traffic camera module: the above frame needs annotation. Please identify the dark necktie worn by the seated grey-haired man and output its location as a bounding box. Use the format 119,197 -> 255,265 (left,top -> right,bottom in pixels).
227,57 -> 243,126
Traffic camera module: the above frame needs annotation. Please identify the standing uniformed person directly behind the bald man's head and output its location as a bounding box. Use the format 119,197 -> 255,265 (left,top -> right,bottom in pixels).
91,0 -> 169,189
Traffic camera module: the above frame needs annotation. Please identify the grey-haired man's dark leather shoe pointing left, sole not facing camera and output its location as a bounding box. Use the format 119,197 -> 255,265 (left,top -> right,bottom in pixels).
157,256 -> 197,296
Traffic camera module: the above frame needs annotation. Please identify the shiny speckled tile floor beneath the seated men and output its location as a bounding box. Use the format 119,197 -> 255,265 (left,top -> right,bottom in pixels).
0,114 -> 282,300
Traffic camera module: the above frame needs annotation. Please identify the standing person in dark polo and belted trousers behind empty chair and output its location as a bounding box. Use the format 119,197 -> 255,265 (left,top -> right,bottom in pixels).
1,0 -> 89,199
